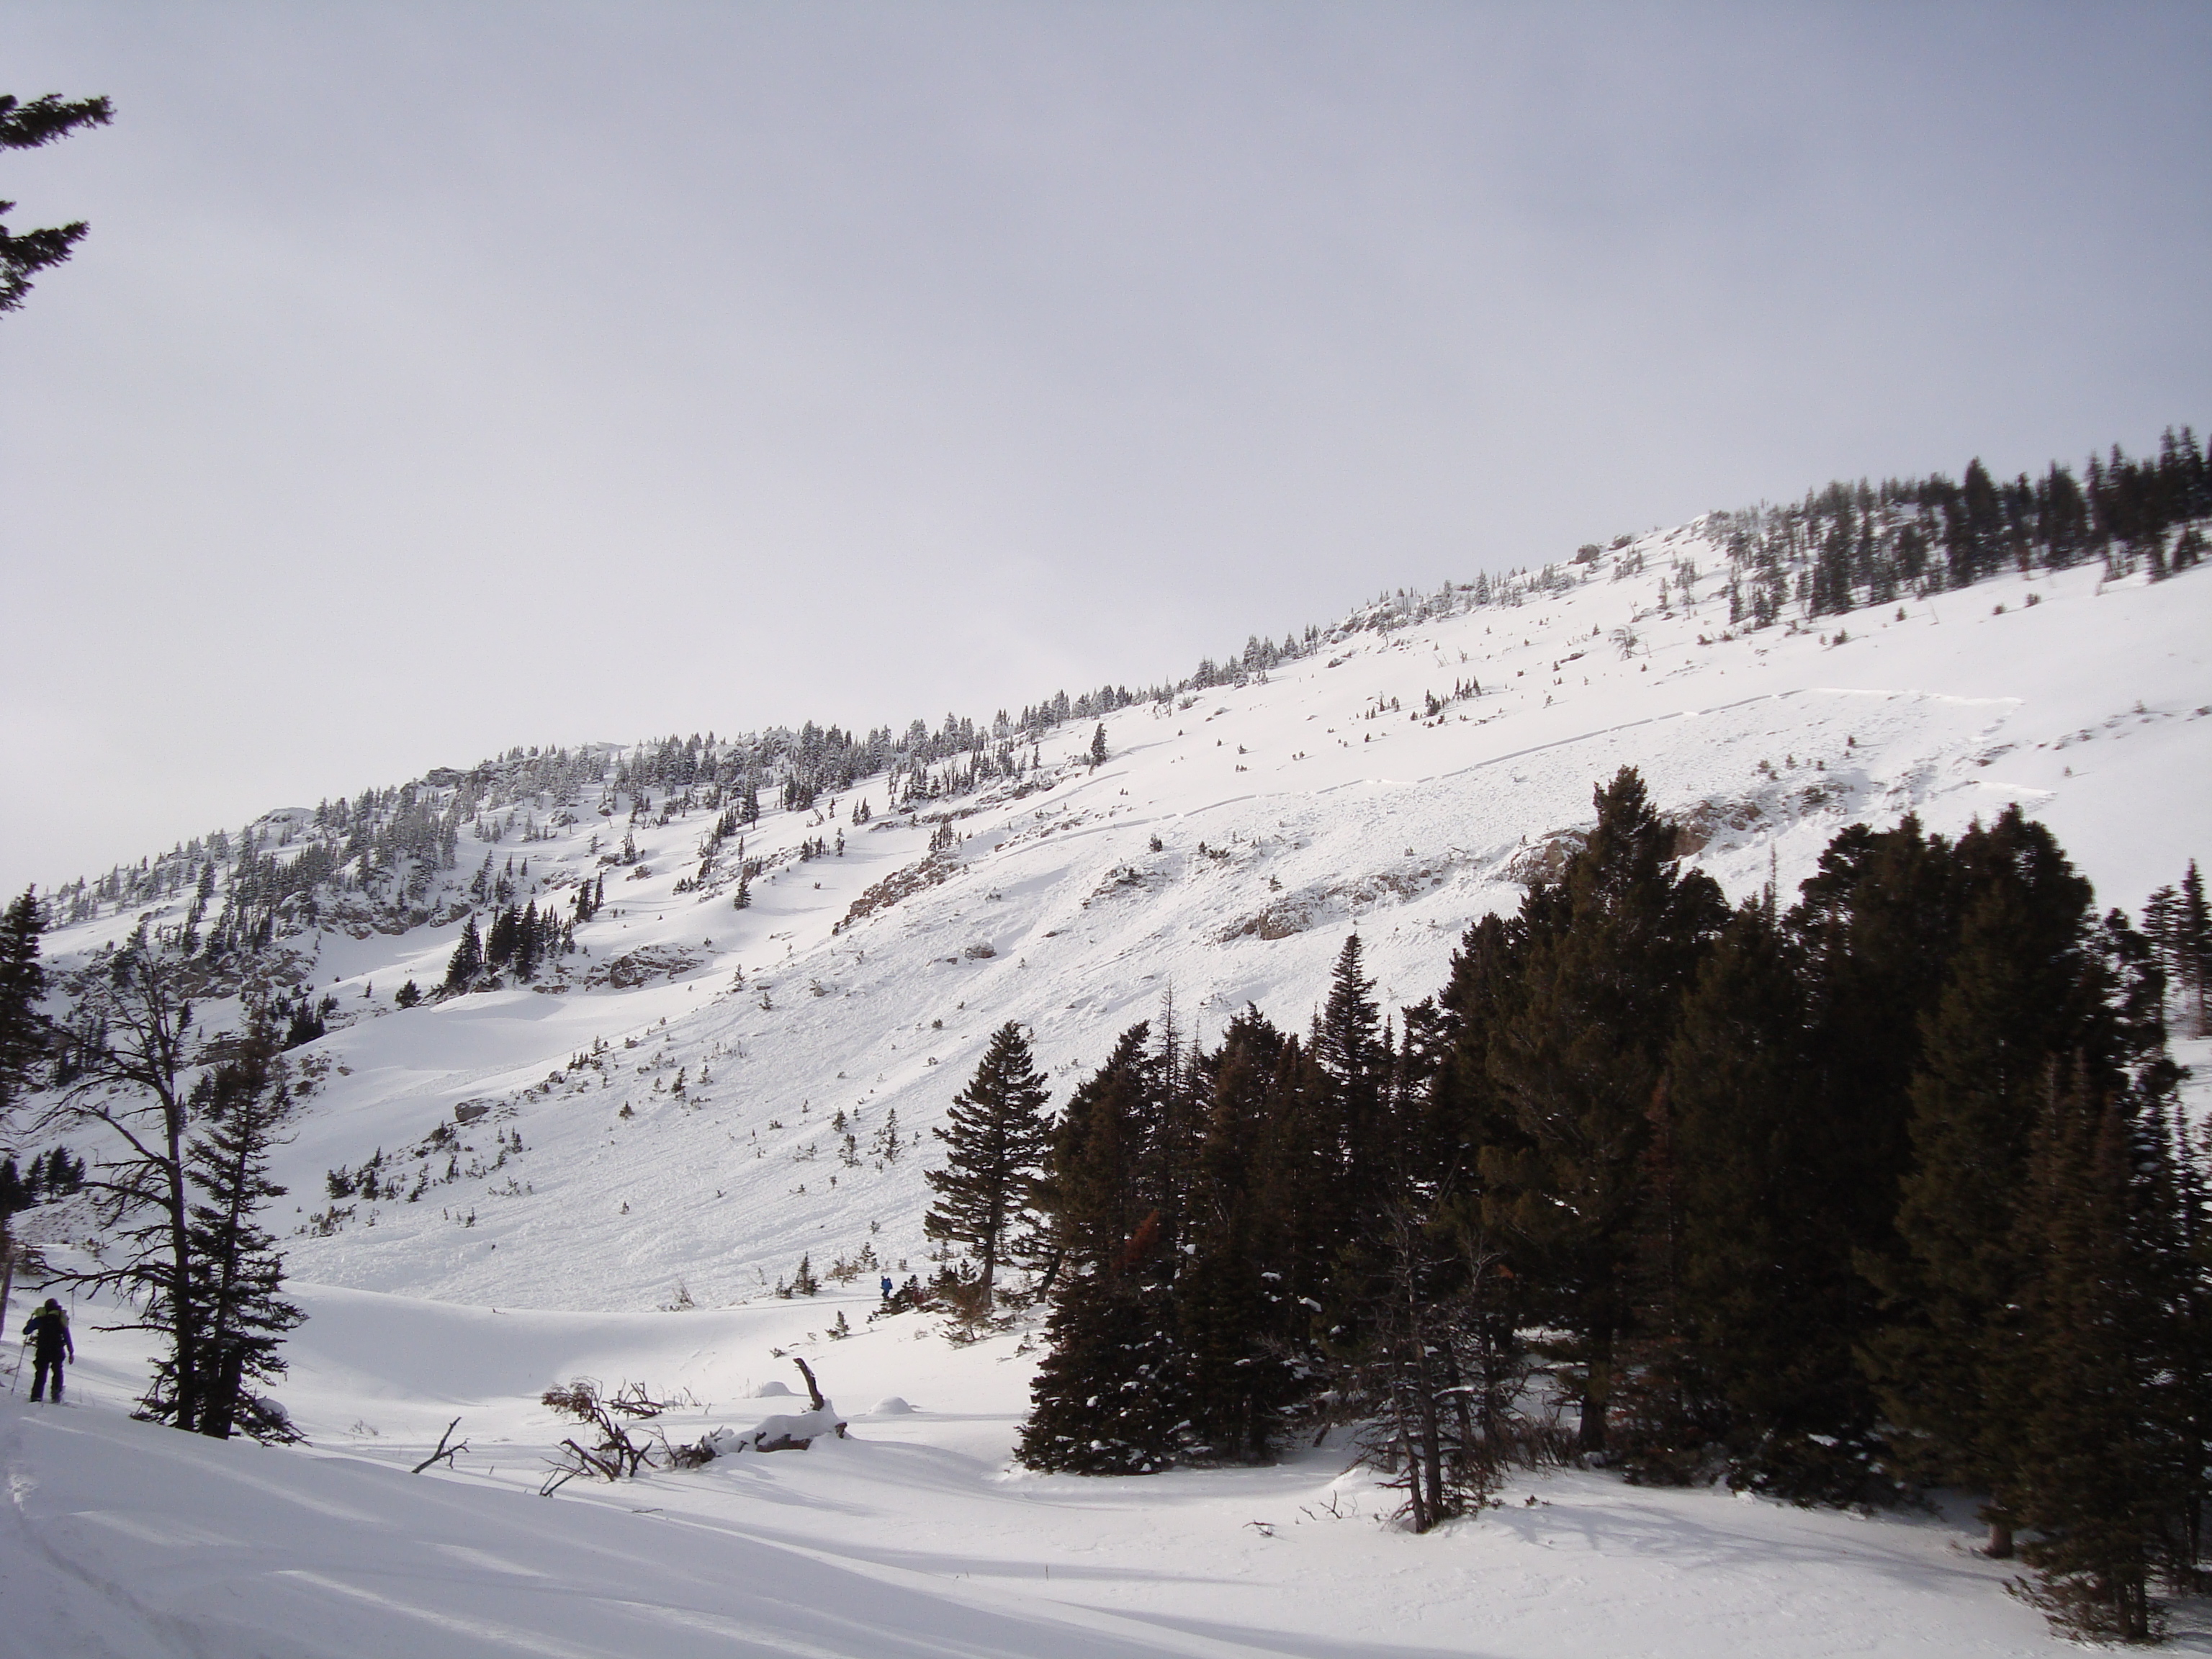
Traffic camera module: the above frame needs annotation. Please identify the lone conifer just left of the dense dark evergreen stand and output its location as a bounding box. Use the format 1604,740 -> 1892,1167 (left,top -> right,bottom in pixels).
922,1020 -> 1051,1310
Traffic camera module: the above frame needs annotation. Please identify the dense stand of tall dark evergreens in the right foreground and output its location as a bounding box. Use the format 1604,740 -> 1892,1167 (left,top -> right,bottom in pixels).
1008,770 -> 2212,1635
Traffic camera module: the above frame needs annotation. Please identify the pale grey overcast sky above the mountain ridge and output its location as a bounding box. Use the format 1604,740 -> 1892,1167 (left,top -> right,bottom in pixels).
0,0 -> 2212,891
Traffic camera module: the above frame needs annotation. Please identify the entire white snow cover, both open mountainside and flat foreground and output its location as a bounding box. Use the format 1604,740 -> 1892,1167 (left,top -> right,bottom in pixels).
0,539 -> 2212,1659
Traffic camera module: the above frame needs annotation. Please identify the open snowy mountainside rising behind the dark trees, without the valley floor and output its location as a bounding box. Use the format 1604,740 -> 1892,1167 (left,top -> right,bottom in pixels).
21,526 -> 2212,1310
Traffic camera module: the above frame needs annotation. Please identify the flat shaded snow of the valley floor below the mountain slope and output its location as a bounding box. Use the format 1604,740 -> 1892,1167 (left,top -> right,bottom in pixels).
0,1287 -> 2212,1659
